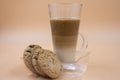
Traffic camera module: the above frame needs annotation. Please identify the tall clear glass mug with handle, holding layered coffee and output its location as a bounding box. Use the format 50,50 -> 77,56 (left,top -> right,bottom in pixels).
48,3 -> 87,70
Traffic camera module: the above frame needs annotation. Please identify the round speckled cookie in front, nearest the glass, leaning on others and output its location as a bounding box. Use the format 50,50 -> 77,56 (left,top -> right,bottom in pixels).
38,49 -> 62,78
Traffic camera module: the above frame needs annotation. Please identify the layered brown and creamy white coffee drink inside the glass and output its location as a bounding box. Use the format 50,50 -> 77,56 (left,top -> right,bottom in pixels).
50,18 -> 80,63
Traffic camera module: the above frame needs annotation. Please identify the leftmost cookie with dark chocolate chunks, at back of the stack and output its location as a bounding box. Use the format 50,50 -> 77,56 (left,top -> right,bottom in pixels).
23,45 -> 41,74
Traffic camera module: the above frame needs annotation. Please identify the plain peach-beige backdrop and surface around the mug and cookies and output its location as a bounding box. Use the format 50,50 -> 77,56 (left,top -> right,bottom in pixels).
0,0 -> 120,80
